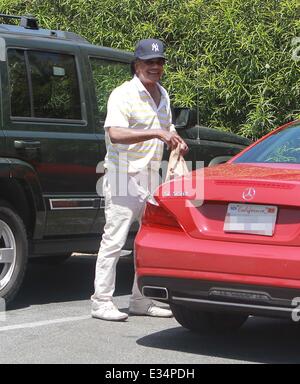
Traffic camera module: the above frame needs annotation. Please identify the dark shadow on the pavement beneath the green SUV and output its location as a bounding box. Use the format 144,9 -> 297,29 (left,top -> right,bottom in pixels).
8,255 -> 134,310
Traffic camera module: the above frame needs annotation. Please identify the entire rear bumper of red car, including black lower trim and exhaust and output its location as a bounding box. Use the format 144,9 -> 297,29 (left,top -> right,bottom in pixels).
135,227 -> 300,318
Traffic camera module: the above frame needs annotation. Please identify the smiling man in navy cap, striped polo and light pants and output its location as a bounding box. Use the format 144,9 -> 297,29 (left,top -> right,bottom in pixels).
91,39 -> 188,321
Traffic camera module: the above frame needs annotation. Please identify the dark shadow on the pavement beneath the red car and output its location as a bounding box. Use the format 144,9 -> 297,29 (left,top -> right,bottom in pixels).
137,318 -> 300,364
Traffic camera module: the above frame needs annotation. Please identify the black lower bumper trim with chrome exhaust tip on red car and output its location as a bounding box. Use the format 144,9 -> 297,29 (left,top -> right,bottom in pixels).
138,276 -> 300,321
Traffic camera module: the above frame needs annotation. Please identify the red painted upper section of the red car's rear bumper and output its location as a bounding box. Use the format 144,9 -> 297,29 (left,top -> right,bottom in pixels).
135,226 -> 300,289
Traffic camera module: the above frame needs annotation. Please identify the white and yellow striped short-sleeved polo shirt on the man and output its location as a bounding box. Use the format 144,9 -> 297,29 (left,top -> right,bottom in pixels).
104,76 -> 175,173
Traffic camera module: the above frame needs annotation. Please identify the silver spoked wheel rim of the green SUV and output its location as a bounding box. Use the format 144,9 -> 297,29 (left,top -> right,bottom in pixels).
0,220 -> 17,290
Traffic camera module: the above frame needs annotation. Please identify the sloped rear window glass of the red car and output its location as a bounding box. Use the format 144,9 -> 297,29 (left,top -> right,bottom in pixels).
234,125 -> 300,164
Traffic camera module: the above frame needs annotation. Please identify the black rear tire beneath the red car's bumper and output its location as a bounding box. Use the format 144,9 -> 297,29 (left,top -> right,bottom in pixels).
170,303 -> 248,334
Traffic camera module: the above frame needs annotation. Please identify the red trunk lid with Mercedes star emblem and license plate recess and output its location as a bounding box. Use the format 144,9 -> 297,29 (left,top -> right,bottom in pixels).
156,164 -> 300,246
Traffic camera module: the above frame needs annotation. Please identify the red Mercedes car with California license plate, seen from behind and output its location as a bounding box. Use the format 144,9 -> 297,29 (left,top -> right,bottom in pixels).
135,121 -> 300,332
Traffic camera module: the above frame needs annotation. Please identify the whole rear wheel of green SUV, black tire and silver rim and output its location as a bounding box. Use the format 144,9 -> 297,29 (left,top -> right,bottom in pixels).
0,200 -> 28,304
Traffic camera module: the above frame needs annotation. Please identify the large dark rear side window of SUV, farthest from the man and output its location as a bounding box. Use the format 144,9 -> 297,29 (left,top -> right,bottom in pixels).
8,49 -> 81,120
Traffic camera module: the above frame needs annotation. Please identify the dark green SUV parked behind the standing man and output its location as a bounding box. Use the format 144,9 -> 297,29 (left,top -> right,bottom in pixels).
0,15 -> 250,301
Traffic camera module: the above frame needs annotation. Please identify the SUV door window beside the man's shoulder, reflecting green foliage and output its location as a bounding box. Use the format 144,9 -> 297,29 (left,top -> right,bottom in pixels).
90,57 -> 131,122
